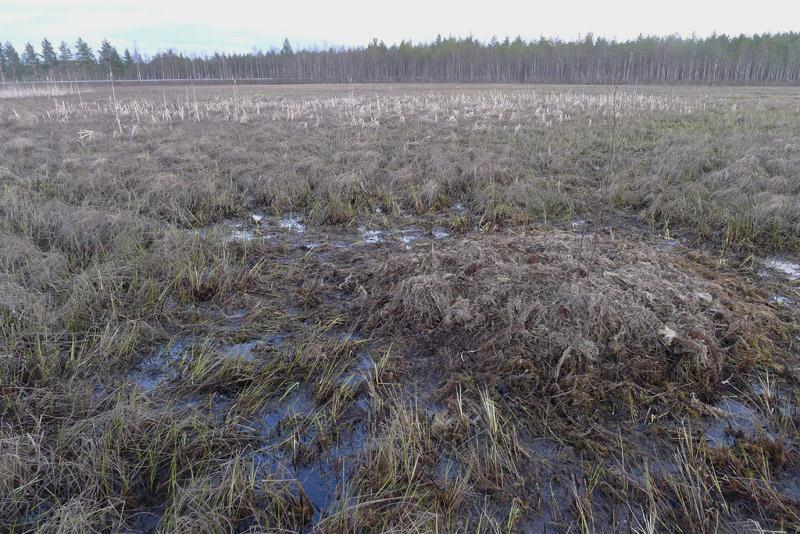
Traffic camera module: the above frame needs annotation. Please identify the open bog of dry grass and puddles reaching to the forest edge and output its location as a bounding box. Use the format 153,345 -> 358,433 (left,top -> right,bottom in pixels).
0,85 -> 800,533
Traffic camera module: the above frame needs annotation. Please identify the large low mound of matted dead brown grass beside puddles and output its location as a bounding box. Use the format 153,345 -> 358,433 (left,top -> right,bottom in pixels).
350,232 -> 786,410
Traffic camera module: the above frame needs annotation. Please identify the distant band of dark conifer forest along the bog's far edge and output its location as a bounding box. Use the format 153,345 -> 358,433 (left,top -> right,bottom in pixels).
0,32 -> 800,84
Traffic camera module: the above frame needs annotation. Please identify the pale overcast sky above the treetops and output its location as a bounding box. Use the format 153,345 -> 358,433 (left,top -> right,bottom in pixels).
0,0 -> 800,54
